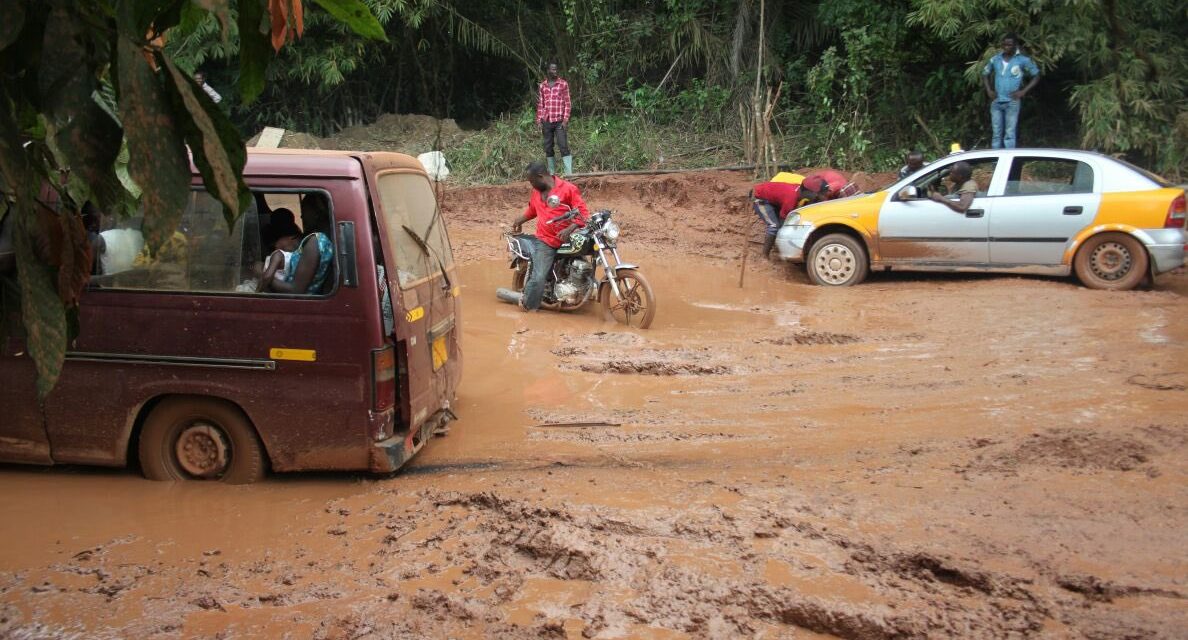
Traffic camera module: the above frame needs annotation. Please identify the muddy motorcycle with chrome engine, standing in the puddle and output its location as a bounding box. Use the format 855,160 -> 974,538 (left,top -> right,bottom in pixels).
495,209 -> 656,329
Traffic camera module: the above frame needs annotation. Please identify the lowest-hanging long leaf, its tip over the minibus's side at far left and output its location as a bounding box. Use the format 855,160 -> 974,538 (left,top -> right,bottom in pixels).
13,205 -> 68,400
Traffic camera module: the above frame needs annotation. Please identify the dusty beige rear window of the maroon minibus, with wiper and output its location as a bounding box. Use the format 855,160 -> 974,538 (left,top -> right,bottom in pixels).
377,172 -> 454,289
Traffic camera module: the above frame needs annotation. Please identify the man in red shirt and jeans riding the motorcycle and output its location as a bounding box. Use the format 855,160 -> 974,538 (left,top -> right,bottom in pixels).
512,161 -> 589,311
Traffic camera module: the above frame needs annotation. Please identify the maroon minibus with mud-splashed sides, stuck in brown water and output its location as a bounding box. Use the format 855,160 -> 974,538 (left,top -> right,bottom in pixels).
0,150 -> 461,482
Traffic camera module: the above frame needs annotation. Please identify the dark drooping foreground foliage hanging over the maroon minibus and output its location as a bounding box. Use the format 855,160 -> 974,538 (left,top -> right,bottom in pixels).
0,0 -> 384,398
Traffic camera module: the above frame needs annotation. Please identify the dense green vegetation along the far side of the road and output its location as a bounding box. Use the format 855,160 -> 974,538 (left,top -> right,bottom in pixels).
170,0 -> 1188,178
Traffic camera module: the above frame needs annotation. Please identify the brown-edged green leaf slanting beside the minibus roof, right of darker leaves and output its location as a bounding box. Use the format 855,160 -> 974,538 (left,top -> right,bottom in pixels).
159,55 -> 252,228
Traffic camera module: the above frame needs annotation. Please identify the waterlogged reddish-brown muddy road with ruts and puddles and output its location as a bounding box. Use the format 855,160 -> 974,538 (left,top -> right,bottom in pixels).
0,175 -> 1188,639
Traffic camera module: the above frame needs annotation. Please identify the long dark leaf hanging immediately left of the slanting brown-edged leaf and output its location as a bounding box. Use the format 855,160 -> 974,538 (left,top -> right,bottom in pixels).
116,37 -> 190,251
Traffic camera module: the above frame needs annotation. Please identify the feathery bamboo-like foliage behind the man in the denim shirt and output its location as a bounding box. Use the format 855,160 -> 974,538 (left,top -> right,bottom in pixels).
909,0 -> 1188,177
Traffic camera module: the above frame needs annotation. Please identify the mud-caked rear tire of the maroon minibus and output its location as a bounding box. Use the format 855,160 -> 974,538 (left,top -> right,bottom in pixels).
137,397 -> 266,484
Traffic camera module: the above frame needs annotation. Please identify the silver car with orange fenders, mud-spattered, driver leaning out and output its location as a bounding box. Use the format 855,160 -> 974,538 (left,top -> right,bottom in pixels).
776,148 -> 1188,290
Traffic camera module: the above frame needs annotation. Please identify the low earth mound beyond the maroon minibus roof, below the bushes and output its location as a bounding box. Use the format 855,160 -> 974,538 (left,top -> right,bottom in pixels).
321,113 -> 466,156
